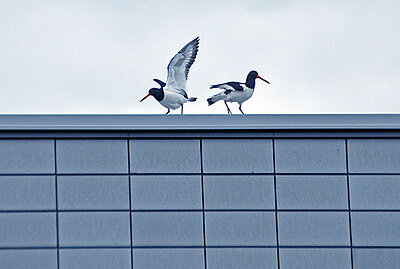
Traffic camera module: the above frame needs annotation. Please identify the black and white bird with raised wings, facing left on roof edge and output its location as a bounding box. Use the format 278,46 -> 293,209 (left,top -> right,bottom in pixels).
140,37 -> 200,114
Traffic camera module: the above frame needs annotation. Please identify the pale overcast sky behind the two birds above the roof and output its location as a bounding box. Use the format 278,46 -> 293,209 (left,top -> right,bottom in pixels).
0,0 -> 400,114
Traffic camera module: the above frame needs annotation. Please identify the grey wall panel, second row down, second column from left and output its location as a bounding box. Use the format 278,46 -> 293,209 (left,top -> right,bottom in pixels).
57,176 -> 129,210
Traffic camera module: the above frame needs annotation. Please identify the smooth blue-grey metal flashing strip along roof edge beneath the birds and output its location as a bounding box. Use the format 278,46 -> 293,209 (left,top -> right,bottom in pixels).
0,114 -> 400,131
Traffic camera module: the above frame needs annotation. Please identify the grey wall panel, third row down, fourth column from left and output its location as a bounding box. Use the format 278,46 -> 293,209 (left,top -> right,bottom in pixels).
205,212 -> 276,246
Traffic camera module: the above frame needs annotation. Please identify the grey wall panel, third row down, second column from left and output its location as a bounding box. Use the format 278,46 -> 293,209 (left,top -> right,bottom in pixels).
58,212 -> 130,247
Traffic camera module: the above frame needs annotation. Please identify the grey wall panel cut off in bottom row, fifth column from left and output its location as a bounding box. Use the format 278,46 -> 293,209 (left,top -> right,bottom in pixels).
279,248 -> 352,269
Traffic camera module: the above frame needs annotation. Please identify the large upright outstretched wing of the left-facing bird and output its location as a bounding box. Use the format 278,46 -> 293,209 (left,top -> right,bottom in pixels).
167,37 -> 200,95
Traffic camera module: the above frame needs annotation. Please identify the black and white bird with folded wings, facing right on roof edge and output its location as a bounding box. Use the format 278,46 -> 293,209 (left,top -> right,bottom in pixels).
207,70 -> 270,114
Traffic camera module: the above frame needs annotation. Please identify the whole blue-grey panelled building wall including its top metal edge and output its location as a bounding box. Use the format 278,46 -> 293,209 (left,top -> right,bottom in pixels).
0,115 -> 400,269
